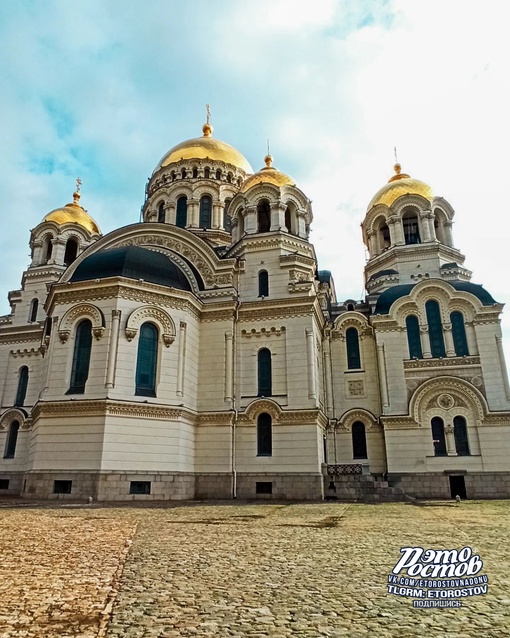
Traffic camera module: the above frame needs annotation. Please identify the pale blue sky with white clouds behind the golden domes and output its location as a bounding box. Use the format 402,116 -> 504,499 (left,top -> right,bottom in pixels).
0,0 -> 510,360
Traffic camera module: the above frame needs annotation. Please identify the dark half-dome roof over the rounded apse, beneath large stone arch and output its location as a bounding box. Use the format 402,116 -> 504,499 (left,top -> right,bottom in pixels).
71,246 -> 191,290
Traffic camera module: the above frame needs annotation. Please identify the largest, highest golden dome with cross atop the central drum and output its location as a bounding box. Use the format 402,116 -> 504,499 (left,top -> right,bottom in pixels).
154,122 -> 253,174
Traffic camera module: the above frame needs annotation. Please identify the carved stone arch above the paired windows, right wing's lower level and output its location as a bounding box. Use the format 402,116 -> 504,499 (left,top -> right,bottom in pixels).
409,376 -> 489,425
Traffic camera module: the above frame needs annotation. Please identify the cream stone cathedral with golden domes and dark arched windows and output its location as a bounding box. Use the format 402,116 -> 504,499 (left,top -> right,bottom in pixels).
0,118 -> 510,501
